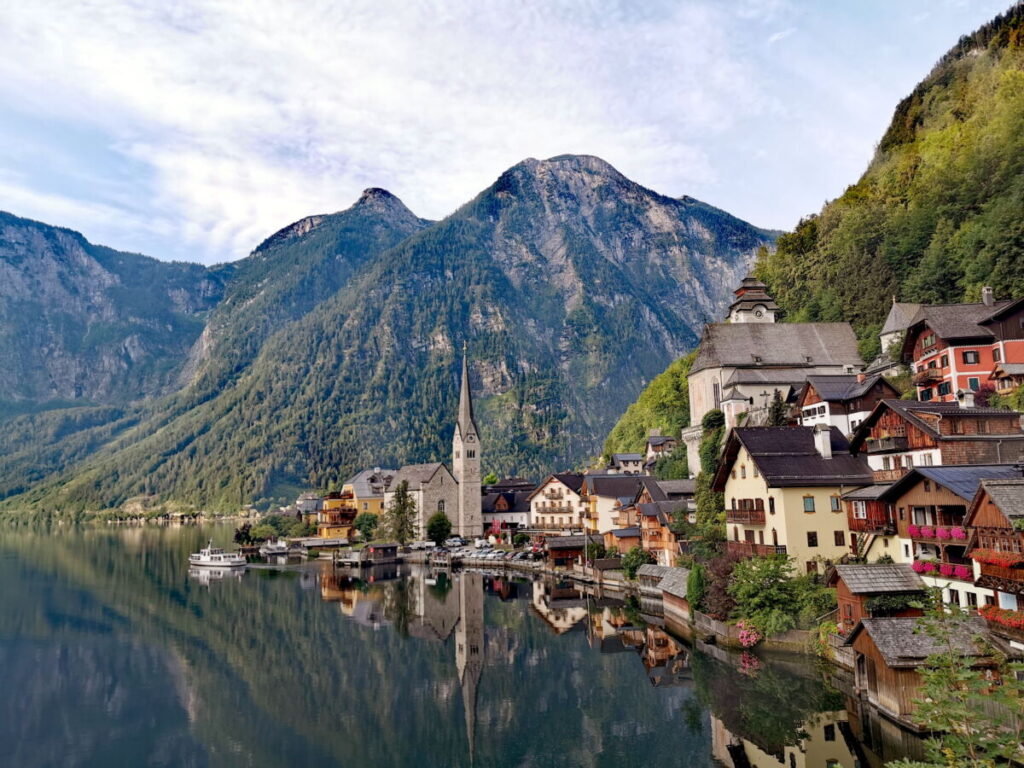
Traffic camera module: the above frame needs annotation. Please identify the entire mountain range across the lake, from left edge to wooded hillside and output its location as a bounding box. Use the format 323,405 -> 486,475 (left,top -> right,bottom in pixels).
0,156 -> 776,511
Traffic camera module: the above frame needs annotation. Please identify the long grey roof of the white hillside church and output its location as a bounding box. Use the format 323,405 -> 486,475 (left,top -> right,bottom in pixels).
690,323 -> 863,374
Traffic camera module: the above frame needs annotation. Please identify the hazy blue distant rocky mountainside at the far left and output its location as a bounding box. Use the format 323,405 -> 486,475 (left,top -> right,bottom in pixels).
0,212 -> 224,410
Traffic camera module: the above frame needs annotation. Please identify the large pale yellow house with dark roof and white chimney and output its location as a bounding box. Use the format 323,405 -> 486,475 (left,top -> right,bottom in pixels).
714,425 -> 872,572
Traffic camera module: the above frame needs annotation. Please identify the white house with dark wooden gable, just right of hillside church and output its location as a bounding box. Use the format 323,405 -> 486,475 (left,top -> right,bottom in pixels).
797,374 -> 899,435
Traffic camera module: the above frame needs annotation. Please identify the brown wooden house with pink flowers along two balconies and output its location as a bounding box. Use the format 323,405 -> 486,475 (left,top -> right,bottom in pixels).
882,464 -> 1022,609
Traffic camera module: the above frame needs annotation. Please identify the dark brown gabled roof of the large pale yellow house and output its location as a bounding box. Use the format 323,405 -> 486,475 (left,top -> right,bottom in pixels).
715,427 -> 874,490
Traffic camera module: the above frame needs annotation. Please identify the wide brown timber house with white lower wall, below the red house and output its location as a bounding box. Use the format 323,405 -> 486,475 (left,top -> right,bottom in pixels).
850,399 -> 1024,482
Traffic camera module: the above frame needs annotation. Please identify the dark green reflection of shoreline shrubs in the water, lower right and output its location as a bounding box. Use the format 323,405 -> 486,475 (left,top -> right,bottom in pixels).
690,650 -> 844,756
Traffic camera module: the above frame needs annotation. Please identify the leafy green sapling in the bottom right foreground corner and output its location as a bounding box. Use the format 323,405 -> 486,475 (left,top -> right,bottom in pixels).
889,590 -> 1024,768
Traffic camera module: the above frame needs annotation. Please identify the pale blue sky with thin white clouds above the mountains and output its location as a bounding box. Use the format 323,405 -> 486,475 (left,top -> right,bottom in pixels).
0,0 -> 1009,264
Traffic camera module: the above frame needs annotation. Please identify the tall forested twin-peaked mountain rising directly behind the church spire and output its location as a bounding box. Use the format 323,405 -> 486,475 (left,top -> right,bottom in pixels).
0,156 -> 773,509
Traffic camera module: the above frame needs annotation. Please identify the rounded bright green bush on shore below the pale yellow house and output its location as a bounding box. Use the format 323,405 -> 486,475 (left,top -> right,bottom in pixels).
727,555 -> 799,636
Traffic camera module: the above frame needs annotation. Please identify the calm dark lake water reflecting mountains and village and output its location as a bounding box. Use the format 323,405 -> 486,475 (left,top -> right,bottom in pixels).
0,526 -> 915,768
